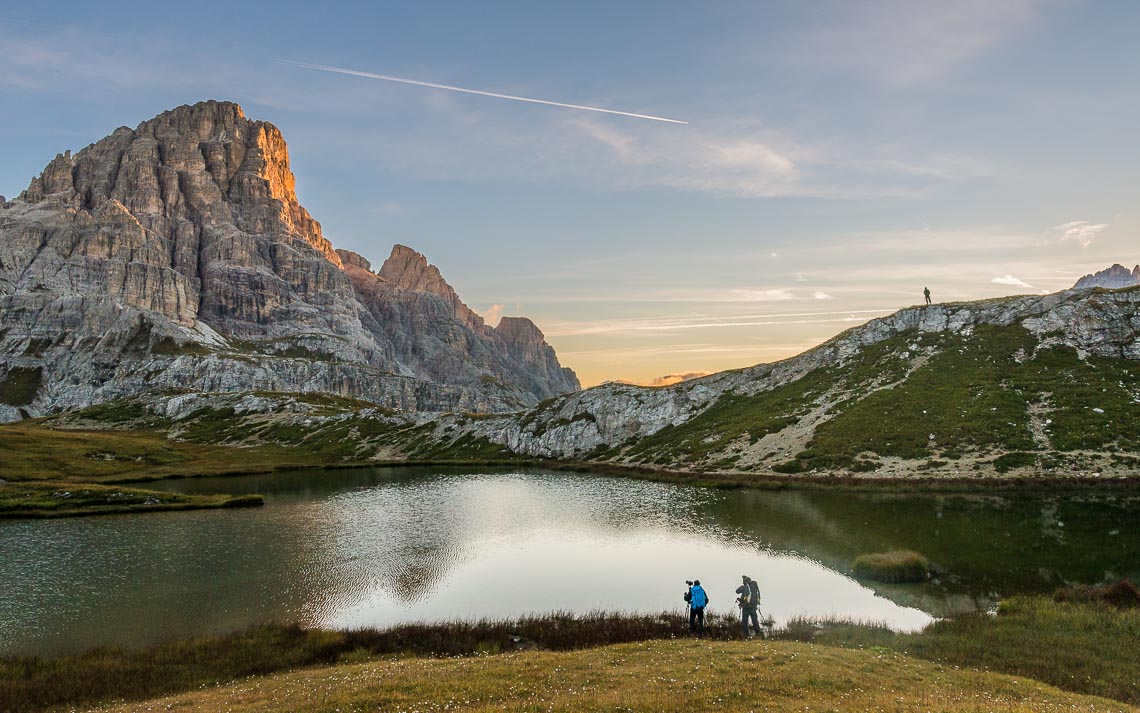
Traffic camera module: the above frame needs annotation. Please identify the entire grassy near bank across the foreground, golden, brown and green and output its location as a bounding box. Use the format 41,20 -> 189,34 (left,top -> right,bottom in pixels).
0,585 -> 1140,713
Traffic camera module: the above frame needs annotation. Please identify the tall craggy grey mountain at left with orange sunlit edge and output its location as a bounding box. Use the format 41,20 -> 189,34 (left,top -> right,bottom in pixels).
0,102 -> 580,421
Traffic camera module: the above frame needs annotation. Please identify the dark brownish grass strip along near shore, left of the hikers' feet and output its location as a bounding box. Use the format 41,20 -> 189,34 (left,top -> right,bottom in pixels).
0,614 -> 740,713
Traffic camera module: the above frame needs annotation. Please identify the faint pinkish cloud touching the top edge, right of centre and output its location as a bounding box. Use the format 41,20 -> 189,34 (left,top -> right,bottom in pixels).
806,0 -> 1052,87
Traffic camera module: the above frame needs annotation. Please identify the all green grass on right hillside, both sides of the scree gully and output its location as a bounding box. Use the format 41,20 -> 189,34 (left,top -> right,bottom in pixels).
624,326 -> 1140,473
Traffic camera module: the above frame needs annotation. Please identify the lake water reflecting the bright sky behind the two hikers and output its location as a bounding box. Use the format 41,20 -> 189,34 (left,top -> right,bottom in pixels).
0,468 -> 1140,654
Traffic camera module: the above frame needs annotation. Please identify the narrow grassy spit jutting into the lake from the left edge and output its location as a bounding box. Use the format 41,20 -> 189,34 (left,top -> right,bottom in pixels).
0,481 -> 264,519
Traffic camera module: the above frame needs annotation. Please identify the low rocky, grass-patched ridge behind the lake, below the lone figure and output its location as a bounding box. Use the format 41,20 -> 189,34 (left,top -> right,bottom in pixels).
75,286 -> 1140,481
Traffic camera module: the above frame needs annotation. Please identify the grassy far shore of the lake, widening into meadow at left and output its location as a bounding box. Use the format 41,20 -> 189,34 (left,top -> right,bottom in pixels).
0,423 -> 1140,518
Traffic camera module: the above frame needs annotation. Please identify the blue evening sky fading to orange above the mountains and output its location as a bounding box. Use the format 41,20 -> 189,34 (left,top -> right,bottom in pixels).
0,0 -> 1140,386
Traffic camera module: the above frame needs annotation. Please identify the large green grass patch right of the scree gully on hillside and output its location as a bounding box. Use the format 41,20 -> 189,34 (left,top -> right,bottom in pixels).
801,325 -> 1140,472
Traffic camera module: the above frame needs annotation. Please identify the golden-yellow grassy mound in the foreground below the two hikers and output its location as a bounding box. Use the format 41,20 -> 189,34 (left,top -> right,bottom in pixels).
86,640 -> 1134,712
